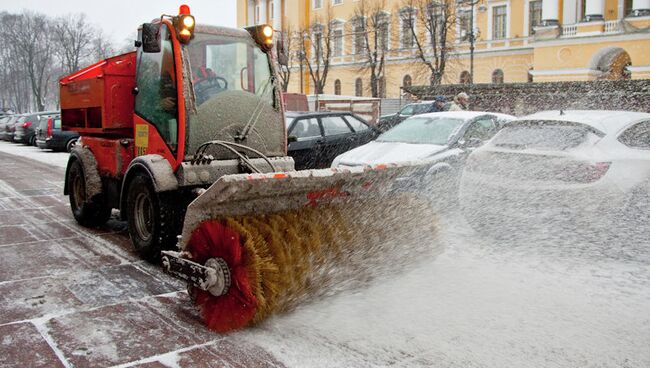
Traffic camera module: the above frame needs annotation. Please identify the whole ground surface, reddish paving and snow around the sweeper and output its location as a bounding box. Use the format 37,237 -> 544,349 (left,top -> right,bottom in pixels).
0,142 -> 650,367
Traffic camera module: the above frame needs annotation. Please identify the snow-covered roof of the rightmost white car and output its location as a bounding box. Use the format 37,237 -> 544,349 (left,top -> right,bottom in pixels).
515,110 -> 650,134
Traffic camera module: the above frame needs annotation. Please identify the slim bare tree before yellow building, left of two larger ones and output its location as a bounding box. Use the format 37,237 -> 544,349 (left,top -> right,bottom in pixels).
298,8 -> 333,94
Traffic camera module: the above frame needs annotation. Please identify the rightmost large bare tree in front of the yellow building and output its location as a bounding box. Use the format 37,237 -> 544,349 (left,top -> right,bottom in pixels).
400,0 -> 456,85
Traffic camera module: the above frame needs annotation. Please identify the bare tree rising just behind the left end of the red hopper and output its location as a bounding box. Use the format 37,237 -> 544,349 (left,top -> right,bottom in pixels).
52,14 -> 96,74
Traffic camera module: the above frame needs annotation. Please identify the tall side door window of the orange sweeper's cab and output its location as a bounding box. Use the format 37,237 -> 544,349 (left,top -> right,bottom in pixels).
135,25 -> 178,151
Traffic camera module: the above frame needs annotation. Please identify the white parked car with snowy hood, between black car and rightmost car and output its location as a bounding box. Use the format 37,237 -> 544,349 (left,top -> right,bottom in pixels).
332,111 -> 515,198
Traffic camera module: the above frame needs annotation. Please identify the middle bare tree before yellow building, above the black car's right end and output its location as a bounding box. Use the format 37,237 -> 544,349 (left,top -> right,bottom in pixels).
352,0 -> 390,97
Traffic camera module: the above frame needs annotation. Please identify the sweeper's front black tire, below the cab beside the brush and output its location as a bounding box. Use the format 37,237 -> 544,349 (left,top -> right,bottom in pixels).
126,174 -> 185,261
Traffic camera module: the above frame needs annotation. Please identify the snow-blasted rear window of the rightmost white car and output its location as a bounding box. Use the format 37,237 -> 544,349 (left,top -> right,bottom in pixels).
492,121 -> 594,151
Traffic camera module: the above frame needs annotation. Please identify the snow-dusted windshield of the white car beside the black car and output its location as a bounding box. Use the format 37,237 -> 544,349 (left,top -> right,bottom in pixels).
377,117 -> 464,145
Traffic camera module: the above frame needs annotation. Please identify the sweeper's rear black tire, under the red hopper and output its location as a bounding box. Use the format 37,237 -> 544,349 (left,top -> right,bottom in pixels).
67,160 -> 111,227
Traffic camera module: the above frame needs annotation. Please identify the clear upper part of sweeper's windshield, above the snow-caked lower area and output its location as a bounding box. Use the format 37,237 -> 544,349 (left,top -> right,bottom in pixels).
189,33 -> 273,107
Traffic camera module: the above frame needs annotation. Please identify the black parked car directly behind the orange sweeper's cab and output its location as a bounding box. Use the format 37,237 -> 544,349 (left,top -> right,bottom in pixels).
286,112 -> 379,170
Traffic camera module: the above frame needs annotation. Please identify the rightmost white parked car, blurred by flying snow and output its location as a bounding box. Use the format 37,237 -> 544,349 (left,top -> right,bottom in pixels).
461,111 -> 650,235
